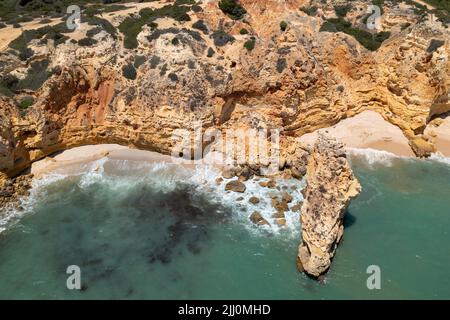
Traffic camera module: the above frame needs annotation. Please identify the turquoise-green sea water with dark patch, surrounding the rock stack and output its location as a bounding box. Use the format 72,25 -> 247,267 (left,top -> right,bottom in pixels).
0,157 -> 450,299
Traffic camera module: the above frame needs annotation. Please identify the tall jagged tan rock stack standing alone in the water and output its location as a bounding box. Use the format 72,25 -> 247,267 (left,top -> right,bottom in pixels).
297,134 -> 361,278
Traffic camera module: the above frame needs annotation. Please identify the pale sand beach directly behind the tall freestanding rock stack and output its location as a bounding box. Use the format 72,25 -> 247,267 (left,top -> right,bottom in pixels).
300,111 -> 414,157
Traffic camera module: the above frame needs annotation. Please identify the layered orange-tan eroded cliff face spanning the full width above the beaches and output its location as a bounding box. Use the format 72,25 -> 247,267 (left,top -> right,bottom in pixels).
0,0 -> 450,180
